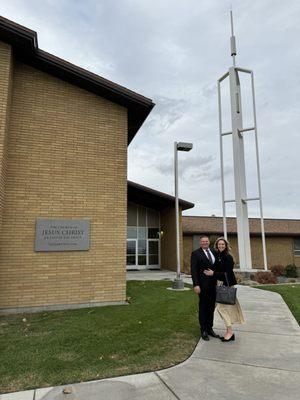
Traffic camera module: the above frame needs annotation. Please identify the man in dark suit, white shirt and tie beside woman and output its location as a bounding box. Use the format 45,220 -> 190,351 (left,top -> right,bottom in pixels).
191,236 -> 219,340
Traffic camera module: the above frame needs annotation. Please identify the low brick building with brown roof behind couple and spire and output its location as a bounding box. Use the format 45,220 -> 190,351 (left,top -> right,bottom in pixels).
182,216 -> 300,273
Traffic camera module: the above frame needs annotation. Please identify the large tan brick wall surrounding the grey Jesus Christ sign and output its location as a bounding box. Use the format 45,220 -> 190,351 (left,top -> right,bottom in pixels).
0,54 -> 127,308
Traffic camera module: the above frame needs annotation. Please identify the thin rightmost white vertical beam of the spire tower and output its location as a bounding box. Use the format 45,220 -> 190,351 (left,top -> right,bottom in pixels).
251,71 -> 268,271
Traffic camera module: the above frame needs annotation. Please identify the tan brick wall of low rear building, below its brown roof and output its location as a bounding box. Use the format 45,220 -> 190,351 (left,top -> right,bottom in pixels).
183,236 -> 297,273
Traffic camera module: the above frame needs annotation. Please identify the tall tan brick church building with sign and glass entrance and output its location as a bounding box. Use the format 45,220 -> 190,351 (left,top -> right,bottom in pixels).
0,17 -> 193,313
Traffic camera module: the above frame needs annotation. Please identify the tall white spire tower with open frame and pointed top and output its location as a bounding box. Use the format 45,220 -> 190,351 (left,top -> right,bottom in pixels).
218,10 -> 267,271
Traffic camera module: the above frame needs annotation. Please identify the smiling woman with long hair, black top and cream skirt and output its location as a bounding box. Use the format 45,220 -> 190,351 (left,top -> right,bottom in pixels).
204,237 -> 245,342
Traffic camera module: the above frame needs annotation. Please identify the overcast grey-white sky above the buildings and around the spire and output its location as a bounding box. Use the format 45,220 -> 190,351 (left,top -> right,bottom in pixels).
0,0 -> 300,218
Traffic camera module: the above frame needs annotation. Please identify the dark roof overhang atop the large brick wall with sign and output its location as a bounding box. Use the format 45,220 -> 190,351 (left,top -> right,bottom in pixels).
0,17 -> 155,144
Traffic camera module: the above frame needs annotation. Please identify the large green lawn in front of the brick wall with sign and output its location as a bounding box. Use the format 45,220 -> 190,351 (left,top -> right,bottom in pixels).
0,281 -> 199,393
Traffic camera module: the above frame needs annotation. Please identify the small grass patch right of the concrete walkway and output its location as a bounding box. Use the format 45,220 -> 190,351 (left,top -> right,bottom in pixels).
255,284 -> 300,324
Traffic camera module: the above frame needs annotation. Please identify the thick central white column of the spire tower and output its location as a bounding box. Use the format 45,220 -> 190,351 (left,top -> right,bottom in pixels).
229,67 -> 252,270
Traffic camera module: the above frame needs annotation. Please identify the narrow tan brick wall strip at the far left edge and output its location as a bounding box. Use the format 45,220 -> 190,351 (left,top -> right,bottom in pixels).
0,42 -> 12,232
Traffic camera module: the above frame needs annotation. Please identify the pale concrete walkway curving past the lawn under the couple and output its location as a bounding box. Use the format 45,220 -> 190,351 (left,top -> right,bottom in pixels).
0,271 -> 300,400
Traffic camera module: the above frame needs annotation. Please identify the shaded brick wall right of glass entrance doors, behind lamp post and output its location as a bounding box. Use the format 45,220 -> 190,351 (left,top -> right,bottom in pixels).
160,207 -> 184,271
